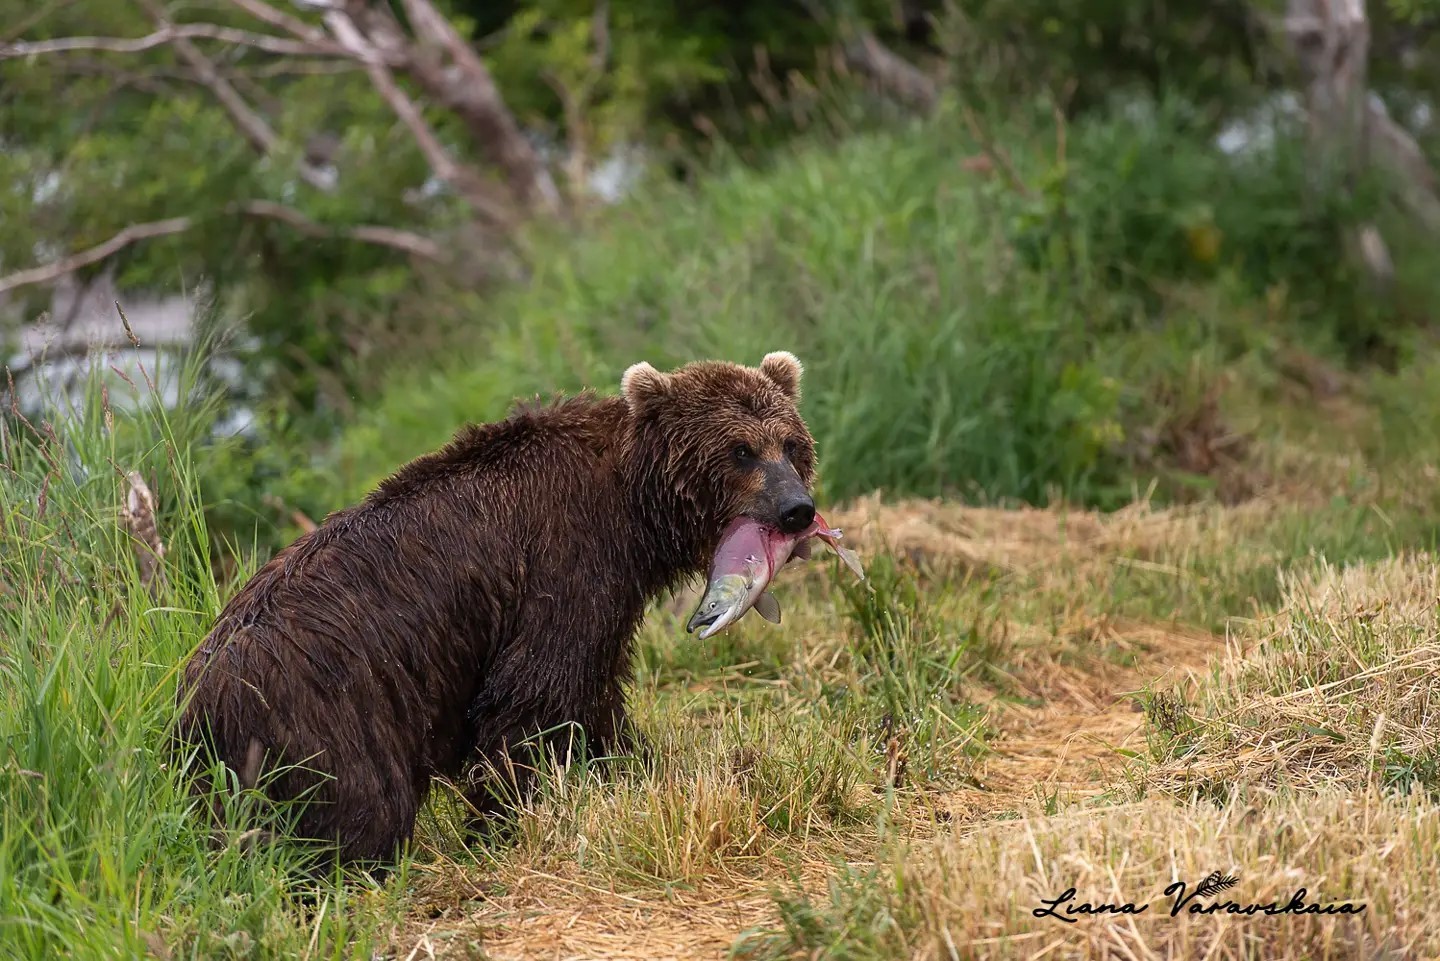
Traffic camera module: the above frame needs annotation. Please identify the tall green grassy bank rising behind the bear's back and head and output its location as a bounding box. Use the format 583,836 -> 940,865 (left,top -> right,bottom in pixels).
253,95 -> 1434,533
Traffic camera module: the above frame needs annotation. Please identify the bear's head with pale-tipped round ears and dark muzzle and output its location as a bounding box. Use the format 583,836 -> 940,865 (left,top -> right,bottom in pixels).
621,350 -> 815,543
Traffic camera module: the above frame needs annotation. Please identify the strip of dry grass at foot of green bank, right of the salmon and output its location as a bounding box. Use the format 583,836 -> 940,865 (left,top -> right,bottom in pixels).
831,489 -> 1436,631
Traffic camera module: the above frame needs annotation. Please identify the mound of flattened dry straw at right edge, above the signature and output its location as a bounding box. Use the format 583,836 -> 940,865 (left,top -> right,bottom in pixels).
1151,556 -> 1440,798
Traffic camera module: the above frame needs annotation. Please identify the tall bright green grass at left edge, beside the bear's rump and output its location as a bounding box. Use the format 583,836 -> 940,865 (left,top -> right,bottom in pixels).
0,358 -> 403,961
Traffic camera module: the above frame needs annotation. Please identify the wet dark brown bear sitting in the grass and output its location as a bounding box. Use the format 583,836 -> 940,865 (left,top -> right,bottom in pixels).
177,352 -> 815,870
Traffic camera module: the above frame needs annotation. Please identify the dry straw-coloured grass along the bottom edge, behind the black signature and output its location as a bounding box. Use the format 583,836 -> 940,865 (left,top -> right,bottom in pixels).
746,790 -> 1440,961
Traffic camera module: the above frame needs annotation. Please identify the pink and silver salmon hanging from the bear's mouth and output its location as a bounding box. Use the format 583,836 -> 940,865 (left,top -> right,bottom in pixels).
685,513 -> 865,640
